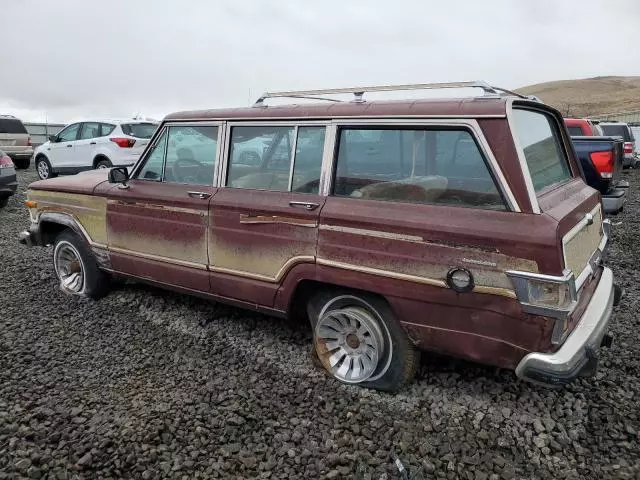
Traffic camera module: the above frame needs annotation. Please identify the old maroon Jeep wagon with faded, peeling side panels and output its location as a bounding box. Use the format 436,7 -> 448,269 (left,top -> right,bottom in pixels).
21,82 -> 621,390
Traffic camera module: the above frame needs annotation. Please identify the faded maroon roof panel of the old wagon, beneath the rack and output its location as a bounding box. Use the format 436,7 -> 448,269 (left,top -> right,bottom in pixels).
164,96 -> 528,121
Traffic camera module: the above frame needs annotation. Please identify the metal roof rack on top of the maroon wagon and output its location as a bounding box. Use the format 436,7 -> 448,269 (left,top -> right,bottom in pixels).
253,80 -> 528,107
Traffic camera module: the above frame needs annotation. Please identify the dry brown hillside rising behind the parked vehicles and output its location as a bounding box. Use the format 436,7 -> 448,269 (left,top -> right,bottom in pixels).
516,77 -> 640,117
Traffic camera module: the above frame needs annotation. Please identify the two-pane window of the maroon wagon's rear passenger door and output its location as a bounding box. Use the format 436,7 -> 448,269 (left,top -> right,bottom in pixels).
227,126 -> 325,194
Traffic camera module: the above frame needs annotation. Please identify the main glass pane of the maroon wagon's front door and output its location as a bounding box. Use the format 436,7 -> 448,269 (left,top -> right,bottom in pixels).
163,125 -> 218,185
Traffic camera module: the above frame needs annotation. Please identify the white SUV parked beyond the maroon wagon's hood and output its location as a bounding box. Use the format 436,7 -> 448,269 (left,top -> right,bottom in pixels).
34,120 -> 158,180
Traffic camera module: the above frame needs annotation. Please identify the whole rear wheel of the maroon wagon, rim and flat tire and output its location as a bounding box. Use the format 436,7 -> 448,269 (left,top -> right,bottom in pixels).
308,292 -> 420,391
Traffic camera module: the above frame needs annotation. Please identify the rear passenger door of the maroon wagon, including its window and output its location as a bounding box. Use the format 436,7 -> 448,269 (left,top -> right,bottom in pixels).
209,124 -> 326,306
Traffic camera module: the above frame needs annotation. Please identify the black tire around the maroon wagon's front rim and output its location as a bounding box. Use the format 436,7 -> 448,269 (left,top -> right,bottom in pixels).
53,229 -> 110,299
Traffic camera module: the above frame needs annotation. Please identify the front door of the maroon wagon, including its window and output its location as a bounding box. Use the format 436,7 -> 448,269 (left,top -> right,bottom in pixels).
107,124 -> 220,292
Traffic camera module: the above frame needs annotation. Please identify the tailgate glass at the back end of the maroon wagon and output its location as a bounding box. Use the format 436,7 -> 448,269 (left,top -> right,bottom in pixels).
513,109 -> 571,192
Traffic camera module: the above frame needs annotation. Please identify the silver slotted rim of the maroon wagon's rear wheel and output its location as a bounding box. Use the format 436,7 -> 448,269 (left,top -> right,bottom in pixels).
314,305 -> 386,383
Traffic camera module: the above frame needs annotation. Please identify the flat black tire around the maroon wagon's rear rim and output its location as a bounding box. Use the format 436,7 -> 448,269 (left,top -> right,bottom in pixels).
307,290 -> 420,392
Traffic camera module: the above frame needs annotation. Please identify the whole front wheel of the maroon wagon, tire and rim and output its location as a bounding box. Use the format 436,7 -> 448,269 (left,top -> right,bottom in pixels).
53,230 -> 109,298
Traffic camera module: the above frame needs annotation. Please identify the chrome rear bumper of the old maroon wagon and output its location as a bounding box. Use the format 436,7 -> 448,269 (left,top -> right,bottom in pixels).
516,268 -> 622,385
